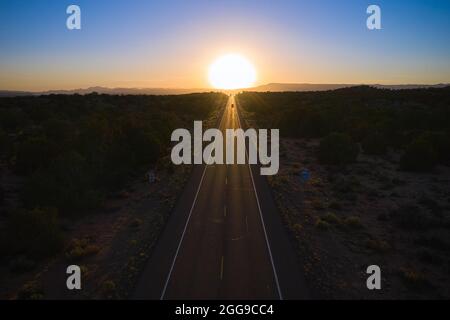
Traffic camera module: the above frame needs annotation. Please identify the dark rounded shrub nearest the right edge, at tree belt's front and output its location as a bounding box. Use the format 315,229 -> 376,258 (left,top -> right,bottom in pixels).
400,138 -> 437,172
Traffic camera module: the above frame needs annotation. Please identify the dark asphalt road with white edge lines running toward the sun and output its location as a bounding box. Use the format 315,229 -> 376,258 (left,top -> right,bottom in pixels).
132,97 -> 308,299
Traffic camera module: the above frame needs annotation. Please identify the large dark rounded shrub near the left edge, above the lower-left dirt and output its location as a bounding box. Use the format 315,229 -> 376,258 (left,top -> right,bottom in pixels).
5,208 -> 63,258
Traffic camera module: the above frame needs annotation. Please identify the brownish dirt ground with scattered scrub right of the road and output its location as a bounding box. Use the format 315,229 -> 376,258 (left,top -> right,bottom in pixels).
269,139 -> 450,299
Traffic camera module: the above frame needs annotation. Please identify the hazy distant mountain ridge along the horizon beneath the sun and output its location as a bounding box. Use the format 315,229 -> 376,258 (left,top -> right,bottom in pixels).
0,83 -> 450,97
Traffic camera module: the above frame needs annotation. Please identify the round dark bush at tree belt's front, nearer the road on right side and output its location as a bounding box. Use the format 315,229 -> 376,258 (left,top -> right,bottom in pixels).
318,133 -> 359,165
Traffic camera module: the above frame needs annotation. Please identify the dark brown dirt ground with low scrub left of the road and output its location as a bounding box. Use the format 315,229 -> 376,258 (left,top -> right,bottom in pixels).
0,159 -> 190,299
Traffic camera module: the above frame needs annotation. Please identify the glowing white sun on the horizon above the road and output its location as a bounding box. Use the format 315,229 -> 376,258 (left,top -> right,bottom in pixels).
209,53 -> 256,90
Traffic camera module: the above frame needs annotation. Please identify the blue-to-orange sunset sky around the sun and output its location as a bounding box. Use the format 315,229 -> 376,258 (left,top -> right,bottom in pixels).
0,0 -> 450,91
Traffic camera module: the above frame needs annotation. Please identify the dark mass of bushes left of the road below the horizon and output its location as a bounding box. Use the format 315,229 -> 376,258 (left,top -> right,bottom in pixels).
0,93 -> 228,218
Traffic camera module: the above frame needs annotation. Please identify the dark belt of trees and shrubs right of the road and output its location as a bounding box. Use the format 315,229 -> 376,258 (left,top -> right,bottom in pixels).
238,86 -> 450,171
